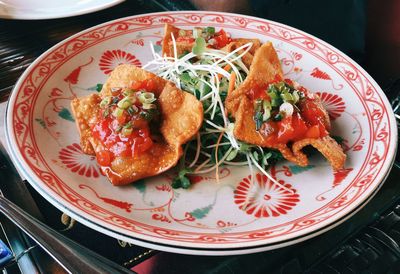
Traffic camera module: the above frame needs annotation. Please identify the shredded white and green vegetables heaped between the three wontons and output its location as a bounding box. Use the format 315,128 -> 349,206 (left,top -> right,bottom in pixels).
143,29 -> 287,190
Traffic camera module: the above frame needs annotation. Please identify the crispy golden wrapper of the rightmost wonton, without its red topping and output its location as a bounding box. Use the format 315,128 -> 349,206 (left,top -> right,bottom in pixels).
225,42 -> 346,170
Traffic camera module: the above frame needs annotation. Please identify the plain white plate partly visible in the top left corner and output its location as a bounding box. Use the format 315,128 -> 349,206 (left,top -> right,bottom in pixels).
0,0 -> 124,20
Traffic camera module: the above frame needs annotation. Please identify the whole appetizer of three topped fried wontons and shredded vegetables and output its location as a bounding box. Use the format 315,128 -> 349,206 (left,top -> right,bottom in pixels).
72,24 -> 346,188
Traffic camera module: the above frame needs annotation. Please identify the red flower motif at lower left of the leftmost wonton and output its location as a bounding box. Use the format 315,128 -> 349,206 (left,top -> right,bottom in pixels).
58,143 -> 100,178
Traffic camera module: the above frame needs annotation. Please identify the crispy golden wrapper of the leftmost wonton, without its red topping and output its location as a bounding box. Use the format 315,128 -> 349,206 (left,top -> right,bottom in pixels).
72,65 -> 203,185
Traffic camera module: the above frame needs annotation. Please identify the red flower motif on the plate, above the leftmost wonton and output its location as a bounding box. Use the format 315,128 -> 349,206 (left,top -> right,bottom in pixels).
99,49 -> 142,74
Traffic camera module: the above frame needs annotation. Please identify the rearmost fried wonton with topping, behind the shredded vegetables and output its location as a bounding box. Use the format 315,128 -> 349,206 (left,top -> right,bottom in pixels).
162,24 -> 261,67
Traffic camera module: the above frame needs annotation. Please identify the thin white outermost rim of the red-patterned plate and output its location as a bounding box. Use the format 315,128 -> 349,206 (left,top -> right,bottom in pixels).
6,11 -> 397,255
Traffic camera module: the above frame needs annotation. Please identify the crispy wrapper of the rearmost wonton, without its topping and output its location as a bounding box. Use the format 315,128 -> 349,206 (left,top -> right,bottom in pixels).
162,24 -> 261,68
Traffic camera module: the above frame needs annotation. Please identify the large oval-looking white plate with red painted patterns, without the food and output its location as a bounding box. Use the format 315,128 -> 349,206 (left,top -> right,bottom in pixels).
7,11 -> 397,255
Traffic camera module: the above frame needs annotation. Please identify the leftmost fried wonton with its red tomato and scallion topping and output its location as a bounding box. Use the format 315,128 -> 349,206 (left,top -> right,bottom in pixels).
71,65 -> 203,185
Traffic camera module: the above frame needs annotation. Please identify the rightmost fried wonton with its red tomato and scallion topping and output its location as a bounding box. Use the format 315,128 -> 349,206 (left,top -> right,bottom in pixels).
225,43 -> 346,170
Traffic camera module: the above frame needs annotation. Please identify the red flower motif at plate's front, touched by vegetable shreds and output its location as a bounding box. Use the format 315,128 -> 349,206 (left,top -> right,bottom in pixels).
234,173 -> 300,218
